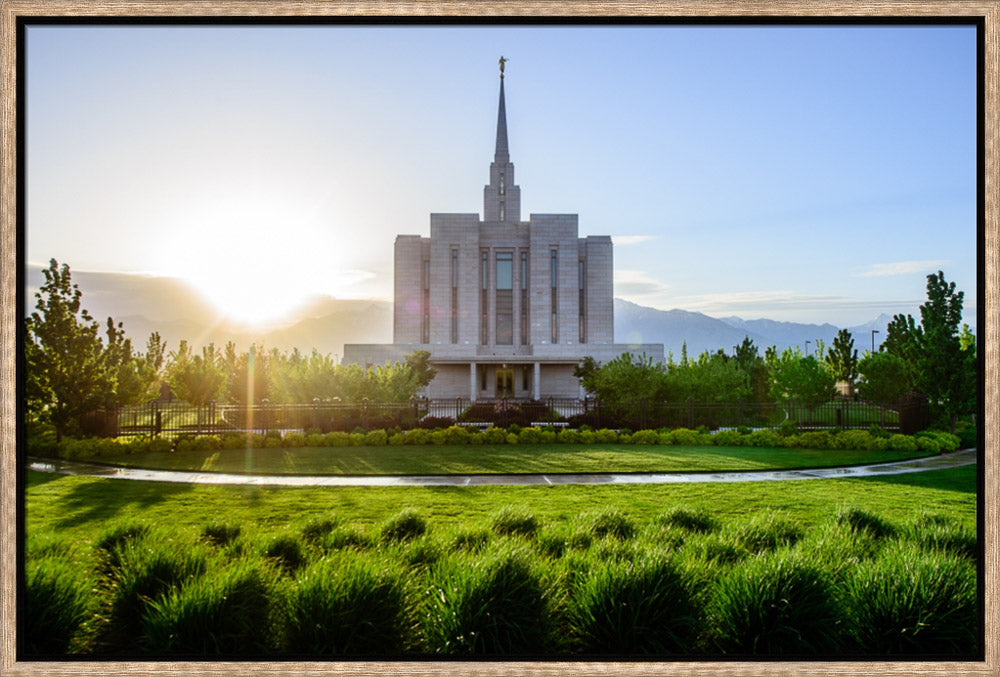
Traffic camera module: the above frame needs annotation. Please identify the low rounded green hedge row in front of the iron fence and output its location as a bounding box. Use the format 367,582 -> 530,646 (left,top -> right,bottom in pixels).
36,426 -> 960,459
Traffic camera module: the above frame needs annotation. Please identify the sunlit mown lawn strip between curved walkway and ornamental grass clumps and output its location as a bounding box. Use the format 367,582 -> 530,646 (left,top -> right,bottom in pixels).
25,466 -> 976,545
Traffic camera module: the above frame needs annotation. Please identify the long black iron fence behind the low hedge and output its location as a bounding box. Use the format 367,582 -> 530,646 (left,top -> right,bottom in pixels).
105,397 -> 926,437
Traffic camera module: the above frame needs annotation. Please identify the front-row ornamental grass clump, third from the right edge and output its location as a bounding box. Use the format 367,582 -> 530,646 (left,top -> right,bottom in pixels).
567,555 -> 701,654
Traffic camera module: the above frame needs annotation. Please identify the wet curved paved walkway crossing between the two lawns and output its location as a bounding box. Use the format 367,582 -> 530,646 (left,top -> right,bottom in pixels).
28,449 -> 977,487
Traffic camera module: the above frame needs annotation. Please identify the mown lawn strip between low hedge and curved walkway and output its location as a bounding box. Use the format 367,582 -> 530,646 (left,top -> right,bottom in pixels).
82,444 -> 927,475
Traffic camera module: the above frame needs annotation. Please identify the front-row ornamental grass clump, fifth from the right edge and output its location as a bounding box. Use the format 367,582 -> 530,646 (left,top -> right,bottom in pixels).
286,557 -> 406,655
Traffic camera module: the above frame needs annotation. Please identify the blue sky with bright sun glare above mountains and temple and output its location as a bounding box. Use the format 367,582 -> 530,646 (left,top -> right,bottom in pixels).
26,26 -> 976,326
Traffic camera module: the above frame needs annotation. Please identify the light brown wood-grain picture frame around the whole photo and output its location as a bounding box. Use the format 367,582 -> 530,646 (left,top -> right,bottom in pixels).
0,0 -> 1000,677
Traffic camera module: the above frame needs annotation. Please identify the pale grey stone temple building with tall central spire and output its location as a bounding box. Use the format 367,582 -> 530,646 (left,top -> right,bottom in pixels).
344,70 -> 663,400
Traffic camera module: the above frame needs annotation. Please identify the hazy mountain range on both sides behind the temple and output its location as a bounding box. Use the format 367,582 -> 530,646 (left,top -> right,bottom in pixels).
25,267 -> 892,360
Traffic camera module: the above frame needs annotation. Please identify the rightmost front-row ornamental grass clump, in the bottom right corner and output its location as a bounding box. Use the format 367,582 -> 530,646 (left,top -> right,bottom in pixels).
845,542 -> 980,655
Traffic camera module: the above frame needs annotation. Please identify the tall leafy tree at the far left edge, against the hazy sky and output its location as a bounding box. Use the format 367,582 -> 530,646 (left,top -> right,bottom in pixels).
24,259 -> 107,441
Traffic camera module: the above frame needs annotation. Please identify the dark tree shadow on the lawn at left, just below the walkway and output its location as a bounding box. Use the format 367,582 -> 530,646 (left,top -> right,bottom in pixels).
55,479 -> 193,528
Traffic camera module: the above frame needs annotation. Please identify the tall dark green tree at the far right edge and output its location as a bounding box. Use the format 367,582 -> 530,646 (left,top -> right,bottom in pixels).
882,271 -> 976,432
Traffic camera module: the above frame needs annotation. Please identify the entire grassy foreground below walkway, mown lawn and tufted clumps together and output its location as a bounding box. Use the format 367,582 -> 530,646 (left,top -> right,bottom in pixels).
25,467 -> 976,656
